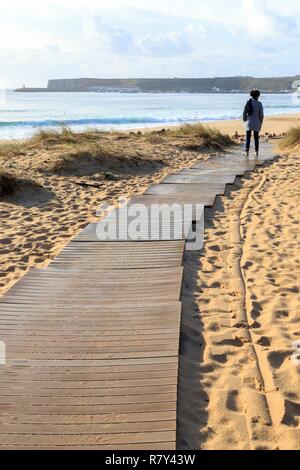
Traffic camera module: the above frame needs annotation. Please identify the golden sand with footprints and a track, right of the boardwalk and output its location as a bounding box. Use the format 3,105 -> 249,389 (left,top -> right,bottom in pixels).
178,149 -> 300,449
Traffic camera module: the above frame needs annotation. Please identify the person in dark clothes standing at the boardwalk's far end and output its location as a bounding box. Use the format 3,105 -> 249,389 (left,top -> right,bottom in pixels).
243,90 -> 264,158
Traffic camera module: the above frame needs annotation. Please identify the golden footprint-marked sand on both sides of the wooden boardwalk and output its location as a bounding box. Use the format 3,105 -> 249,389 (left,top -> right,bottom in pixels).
0,115 -> 300,450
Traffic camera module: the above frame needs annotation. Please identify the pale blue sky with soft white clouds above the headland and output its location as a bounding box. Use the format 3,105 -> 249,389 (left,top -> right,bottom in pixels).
0,0 -> 300,88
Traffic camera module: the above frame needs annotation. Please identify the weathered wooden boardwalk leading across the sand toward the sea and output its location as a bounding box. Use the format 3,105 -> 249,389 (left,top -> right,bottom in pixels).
0,145 -> 273,450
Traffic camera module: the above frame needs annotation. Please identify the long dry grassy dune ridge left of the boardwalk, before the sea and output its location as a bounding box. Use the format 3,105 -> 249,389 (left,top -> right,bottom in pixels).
0,124 -> 233,178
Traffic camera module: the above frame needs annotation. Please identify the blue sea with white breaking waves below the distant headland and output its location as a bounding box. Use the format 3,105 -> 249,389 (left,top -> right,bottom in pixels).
0,91 -> 300,140
